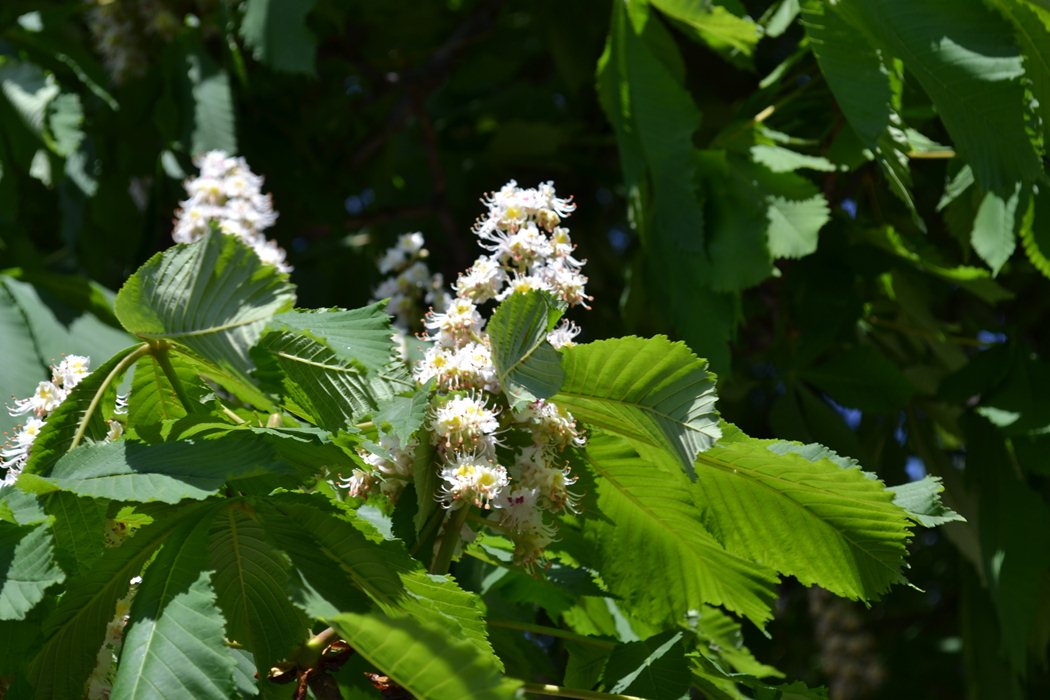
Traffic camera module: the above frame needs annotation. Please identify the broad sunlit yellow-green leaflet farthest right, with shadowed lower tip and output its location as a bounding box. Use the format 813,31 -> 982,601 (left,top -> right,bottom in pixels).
694,428 -> 910,600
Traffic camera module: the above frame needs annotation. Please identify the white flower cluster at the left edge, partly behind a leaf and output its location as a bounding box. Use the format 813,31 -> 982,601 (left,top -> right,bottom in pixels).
0,355 -> 127,486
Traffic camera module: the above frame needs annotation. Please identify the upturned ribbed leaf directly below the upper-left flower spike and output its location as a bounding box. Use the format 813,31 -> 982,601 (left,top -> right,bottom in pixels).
116,231 -> 295,407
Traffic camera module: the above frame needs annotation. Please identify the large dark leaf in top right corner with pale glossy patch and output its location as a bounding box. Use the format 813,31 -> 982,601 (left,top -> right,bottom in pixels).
835,0 -> 1042,197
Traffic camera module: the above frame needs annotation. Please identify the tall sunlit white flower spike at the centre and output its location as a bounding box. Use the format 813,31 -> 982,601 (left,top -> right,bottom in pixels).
343,182 -> 590,567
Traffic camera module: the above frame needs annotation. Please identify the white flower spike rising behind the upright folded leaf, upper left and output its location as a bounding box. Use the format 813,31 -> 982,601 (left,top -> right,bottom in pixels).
171,151 -> 292,272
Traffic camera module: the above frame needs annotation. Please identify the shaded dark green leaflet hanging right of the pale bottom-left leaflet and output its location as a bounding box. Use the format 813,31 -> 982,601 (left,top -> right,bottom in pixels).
208,505 -> 310,678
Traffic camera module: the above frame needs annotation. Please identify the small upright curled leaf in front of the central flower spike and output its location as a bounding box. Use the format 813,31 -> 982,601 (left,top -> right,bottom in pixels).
486,292 -> 564,404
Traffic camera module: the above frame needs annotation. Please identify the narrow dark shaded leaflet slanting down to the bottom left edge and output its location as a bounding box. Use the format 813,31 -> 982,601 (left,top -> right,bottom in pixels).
29,504 -> 211,700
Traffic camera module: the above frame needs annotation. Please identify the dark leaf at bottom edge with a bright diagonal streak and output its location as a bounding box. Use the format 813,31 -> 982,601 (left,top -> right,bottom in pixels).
603,631 -> 690,700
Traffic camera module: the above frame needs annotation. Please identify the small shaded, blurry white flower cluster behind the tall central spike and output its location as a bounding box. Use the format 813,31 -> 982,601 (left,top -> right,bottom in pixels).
372,233 -> 448,333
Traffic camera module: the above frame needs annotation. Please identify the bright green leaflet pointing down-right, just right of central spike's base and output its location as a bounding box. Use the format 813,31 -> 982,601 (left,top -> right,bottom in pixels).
584,434 -> 777,625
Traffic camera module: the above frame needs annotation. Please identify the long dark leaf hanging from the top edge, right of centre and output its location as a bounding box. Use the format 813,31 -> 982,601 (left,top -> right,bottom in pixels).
599,2 -> 736,370
